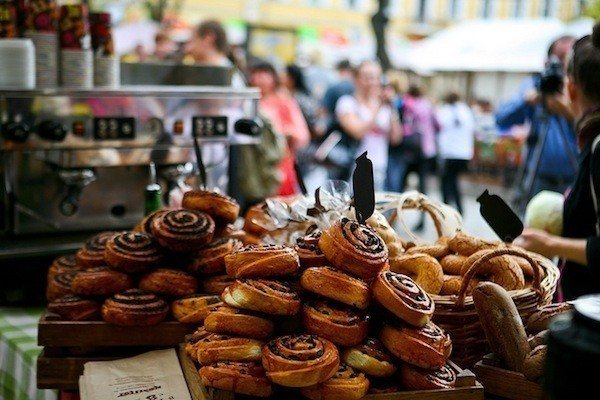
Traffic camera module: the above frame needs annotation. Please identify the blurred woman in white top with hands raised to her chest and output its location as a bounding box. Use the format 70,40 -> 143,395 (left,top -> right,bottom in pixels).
335,61 -> 402,191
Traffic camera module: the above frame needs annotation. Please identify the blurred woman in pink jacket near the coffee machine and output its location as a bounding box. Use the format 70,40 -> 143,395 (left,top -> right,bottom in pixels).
250,62 -> 310,196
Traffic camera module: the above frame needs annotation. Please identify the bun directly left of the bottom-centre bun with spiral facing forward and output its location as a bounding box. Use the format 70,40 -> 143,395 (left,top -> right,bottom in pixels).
190,328 -> 264,365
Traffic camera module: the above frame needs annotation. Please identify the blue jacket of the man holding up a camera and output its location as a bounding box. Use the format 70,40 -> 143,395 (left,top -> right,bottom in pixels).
496,77 -> 577,180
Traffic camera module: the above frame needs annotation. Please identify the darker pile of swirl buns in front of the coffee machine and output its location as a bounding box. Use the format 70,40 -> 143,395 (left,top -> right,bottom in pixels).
46,190 -> 255,326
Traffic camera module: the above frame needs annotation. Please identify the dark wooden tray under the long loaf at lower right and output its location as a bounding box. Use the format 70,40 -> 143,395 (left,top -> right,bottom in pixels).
475,354 -> 543,400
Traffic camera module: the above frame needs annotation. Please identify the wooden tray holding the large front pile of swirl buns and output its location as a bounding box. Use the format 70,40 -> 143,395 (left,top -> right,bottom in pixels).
179,344 -> 483,400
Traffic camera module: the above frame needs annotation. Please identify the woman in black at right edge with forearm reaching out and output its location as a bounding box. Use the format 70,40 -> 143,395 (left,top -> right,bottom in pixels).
514,23 -> 600,301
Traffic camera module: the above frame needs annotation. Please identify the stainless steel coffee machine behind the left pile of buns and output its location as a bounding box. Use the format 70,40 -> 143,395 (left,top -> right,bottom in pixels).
0,86 -> 259,255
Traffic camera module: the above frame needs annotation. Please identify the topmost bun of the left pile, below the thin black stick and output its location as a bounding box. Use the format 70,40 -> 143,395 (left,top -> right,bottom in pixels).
181,190 -> 240,224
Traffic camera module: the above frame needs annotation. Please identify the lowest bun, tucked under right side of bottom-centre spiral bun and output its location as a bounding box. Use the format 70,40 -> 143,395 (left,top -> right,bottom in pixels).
301,363 -> 369,400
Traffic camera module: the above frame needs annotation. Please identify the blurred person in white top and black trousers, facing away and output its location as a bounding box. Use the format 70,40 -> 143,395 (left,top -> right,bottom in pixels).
437,92 -> 475,214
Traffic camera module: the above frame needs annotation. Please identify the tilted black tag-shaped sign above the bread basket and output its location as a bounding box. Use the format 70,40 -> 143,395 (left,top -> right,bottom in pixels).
477,189 -> 523,243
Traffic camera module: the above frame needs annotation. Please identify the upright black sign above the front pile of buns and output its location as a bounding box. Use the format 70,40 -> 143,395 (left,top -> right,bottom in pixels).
352,151 -> 375,224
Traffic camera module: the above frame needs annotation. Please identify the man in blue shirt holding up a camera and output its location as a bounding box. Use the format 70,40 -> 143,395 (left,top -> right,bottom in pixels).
496,36 -> 577,201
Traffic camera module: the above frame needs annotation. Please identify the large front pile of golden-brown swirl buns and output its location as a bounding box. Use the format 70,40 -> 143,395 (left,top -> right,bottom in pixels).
186,218 -> 456,400
